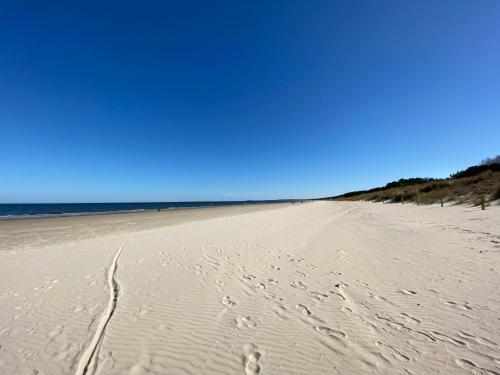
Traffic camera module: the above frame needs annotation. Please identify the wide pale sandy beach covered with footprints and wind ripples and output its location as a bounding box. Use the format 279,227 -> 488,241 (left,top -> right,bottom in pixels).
0,201 -> 500,375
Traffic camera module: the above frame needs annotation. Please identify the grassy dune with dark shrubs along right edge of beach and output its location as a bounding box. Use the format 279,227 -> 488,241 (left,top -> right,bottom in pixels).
325,156 -> 500,206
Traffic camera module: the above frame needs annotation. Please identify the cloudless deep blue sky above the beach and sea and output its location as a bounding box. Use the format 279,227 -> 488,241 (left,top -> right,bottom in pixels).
0,0 -> 500,203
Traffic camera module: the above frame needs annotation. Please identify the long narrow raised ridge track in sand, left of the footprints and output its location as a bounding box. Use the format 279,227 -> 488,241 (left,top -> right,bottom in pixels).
75,240 -> 125,375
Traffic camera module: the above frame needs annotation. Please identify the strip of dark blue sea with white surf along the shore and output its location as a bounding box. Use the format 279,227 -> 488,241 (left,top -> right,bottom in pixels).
0,200 -> 288,219
